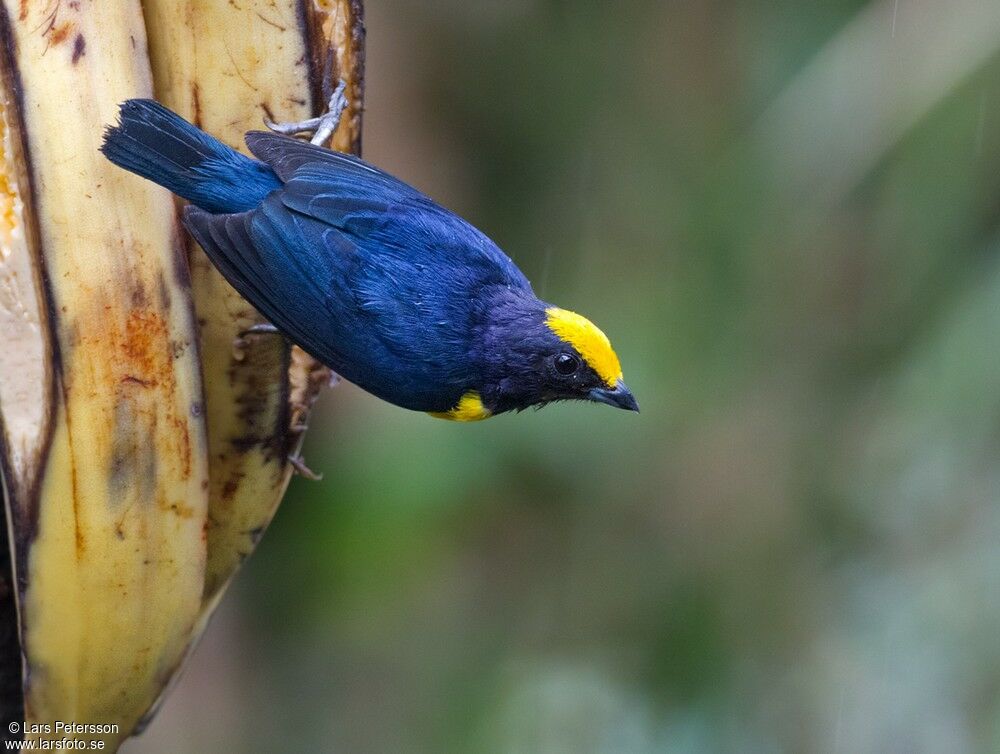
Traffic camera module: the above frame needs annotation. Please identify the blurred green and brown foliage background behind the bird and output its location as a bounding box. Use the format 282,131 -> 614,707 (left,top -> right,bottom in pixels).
129,0 -> 1000,754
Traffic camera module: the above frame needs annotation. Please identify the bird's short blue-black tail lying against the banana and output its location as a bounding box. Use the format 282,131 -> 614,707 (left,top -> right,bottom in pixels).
101,99 -> 281,214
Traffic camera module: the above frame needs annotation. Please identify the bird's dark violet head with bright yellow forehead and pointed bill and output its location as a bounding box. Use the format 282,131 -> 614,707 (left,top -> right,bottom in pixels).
460,288 -> 639,415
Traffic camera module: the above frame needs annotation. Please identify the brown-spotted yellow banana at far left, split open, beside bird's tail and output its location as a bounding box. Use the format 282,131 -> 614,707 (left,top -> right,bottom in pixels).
0,0 -> 208,748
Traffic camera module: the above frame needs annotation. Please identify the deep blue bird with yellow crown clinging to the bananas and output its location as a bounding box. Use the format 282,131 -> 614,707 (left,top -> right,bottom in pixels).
101,88 -> 639,421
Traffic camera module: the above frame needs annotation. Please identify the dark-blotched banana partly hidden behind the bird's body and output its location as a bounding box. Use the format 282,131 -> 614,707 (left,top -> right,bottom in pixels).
143,0 -> 363,619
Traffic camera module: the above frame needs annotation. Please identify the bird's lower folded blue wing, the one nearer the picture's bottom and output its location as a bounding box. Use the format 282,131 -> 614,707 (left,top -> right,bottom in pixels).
184,191 -> 478,410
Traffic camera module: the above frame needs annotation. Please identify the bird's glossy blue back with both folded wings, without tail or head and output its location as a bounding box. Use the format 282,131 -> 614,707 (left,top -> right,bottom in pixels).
185,133 -> 531,411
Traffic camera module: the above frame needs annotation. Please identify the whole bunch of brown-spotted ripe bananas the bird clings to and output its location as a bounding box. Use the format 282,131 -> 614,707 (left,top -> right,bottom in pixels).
0,0 -> 363,750
